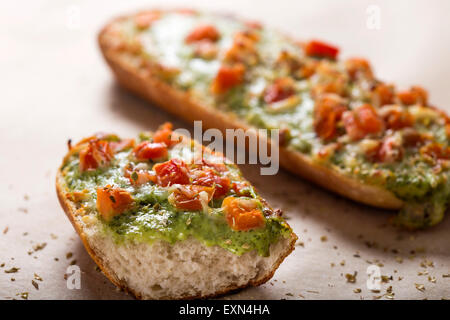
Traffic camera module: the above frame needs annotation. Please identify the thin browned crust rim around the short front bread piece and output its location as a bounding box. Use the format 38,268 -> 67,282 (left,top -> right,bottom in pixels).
56,146 -> 297,300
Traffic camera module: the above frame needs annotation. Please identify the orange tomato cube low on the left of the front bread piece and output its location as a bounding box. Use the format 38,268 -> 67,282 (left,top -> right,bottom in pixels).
97,185 -> 133,221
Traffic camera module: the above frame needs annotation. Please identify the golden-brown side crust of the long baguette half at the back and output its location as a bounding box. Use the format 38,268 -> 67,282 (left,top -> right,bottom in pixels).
98,13 -> 403,209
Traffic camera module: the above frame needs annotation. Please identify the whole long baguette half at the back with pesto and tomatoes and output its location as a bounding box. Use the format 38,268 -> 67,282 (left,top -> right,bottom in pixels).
99,10 -> 450,228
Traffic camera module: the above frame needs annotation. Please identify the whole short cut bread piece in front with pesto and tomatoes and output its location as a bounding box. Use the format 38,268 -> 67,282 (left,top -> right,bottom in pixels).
56,123 -> 297,299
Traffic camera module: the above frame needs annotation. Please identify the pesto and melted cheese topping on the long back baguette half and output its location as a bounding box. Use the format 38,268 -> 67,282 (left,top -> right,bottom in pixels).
113,12 -> 450,228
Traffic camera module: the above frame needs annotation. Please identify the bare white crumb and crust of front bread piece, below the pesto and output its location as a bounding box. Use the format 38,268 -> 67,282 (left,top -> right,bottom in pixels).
56,126 -> 297,299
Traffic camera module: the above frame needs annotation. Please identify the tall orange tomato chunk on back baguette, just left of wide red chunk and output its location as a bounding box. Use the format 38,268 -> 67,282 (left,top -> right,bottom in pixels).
314,95 -> 347,140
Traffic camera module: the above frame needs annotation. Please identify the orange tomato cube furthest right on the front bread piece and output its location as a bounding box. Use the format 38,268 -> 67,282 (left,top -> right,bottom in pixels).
222,196 -> 265,231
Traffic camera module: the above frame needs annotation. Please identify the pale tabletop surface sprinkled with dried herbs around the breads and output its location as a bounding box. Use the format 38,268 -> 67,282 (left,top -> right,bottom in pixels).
0,0 -> 450,299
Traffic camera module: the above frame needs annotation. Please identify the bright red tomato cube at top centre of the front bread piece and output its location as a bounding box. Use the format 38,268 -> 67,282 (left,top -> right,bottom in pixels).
153,159 -> 190,187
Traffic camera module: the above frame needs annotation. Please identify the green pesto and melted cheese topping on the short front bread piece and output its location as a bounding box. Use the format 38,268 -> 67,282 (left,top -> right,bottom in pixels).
61,134 -> 292,256
